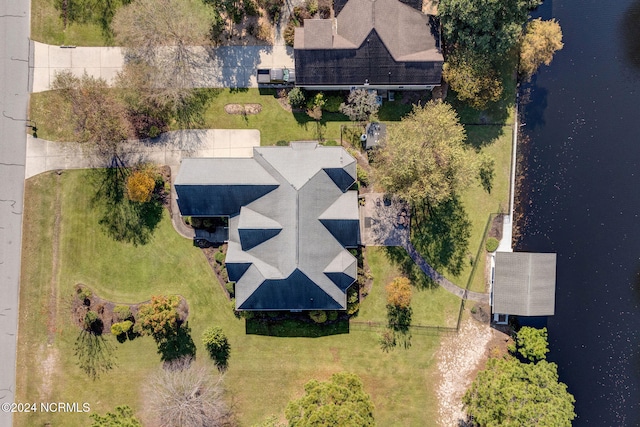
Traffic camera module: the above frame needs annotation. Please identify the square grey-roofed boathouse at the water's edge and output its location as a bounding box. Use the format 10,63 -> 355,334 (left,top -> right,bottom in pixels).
492,252 -> 556,324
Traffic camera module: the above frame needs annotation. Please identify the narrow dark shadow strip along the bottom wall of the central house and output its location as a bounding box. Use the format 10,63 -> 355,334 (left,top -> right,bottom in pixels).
245,318 -> 349,338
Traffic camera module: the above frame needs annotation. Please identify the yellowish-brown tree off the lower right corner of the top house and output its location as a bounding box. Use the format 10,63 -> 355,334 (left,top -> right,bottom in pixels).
442,50 -> 503,110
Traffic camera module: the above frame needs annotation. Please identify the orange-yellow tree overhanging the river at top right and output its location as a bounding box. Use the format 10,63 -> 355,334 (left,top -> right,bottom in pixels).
520,18 -> 564,78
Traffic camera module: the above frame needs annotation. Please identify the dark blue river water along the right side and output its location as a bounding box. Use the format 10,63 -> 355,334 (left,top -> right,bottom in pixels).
516,0 -> 640,426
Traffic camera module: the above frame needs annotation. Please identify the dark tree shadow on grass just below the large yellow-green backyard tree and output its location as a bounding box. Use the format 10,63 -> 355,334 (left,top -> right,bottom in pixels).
411,197 -> 471,276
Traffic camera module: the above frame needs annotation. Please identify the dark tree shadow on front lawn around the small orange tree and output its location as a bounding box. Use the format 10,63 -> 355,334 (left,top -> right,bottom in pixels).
93,167 -> 162,246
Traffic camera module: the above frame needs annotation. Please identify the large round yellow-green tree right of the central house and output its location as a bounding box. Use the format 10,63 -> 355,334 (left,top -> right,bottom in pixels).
375,102 -> 476,206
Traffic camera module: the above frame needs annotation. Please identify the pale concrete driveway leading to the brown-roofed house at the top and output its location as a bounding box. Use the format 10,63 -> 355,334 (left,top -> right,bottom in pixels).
30,42 -> 293,92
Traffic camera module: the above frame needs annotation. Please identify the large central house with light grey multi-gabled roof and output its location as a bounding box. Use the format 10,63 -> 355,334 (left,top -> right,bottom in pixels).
175,143 -> 360,311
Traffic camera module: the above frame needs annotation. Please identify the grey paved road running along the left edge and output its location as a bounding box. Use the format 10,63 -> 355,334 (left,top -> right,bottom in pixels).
0,0 -> 29,427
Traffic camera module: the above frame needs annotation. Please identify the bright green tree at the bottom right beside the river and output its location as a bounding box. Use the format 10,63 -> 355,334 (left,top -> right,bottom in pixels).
462,357 -> 575,427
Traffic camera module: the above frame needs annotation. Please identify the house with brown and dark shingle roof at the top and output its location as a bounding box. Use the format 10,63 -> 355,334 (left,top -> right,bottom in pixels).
294,0 -> 444,90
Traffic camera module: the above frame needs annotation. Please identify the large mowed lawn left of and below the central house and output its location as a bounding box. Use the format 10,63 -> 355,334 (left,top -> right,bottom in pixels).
15,171 -> 450,427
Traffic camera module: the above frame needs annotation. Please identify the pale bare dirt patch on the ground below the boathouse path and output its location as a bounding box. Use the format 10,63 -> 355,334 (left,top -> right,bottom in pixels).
436,319 -> 495,427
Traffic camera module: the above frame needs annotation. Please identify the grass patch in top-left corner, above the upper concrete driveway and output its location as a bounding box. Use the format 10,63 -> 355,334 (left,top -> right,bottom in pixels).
31,0 -> 111,46
